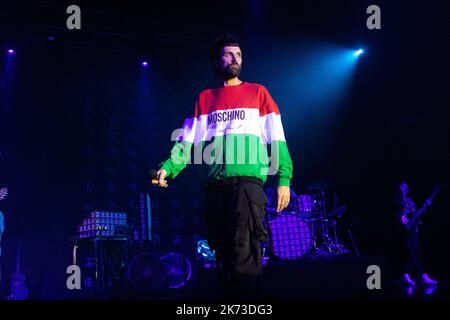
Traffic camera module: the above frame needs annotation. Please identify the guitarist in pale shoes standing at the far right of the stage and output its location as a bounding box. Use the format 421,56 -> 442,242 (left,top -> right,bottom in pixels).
395,182 -> 437,286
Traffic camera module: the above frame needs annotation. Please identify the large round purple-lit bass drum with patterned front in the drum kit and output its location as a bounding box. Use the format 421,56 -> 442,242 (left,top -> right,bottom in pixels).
269,213 -> 313,260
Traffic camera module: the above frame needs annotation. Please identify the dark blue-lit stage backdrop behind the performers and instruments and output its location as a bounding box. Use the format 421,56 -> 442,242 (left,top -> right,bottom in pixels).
0,0 -> 450,299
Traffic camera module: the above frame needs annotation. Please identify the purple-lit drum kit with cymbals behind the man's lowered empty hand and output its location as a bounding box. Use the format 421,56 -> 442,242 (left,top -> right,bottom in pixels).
262,181 -> 351,260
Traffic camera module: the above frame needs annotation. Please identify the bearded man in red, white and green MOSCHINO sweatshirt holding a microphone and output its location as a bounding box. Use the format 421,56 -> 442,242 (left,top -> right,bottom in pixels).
157,34 -> 293,298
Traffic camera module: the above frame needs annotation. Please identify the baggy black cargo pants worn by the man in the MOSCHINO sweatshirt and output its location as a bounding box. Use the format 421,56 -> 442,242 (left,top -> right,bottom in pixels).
205,176 -> 267,299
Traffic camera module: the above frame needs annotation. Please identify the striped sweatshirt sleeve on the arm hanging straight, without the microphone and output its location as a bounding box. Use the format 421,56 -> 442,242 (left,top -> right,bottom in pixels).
260,86 -> 293,186
